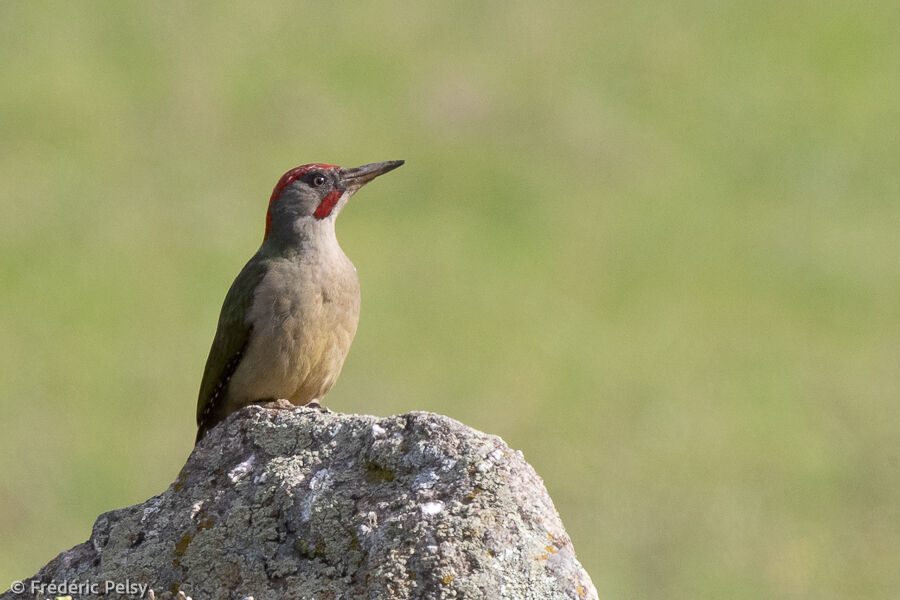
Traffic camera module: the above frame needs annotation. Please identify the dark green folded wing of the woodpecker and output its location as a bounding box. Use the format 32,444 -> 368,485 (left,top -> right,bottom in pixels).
197,254 -> 268,442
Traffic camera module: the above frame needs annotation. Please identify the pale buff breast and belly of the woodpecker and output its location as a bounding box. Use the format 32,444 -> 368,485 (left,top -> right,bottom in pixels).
228,261 -> 359,407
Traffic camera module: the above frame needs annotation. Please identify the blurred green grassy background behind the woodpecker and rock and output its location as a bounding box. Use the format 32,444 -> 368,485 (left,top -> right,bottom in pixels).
0,0 -> 900,598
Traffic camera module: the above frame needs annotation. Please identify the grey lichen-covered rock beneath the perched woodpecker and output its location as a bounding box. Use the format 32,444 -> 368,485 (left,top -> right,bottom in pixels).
3,406 -> 597,600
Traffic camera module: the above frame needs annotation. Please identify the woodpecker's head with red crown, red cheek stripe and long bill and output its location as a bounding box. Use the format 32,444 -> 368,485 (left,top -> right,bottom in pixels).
263,160 -> 403,239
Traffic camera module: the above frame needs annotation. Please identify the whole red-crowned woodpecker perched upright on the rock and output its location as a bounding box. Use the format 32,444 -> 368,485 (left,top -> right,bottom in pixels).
195,160 -> 403,443
